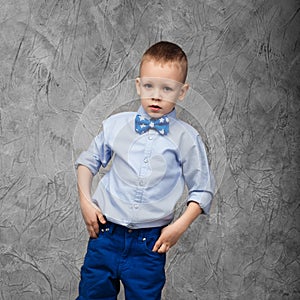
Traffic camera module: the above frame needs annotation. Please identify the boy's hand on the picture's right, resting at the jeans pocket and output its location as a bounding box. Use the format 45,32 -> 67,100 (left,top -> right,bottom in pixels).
152,223 -> 184,253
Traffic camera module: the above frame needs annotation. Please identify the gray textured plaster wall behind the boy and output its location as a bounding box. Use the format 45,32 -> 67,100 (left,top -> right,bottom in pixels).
0,0 -> 300,300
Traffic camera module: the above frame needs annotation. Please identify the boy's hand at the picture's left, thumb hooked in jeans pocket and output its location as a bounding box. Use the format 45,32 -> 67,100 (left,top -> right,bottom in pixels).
80,200 -> 106,238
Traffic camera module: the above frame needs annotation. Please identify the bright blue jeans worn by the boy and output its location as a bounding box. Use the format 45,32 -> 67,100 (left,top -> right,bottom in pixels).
77,222 -> 166,300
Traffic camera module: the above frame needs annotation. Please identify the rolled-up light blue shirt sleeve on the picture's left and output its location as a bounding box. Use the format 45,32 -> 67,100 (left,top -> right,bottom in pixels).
75,131 -> 112,176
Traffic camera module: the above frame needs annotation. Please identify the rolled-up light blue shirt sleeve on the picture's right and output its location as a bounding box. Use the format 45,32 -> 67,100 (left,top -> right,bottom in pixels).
182,136 -> 215,214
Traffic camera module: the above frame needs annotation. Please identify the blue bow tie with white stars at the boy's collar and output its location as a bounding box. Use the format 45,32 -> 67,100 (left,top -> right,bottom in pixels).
135,115 -> 169,135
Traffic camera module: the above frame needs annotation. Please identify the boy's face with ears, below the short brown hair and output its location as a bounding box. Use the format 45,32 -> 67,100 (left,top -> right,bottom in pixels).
136,60 -> 189,119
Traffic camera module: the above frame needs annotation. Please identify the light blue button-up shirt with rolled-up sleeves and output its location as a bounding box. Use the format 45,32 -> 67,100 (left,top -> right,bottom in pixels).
75,107 -> 214,228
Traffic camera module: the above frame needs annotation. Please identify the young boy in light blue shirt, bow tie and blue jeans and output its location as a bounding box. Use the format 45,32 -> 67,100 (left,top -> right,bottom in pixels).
76,42 -> 214,300
